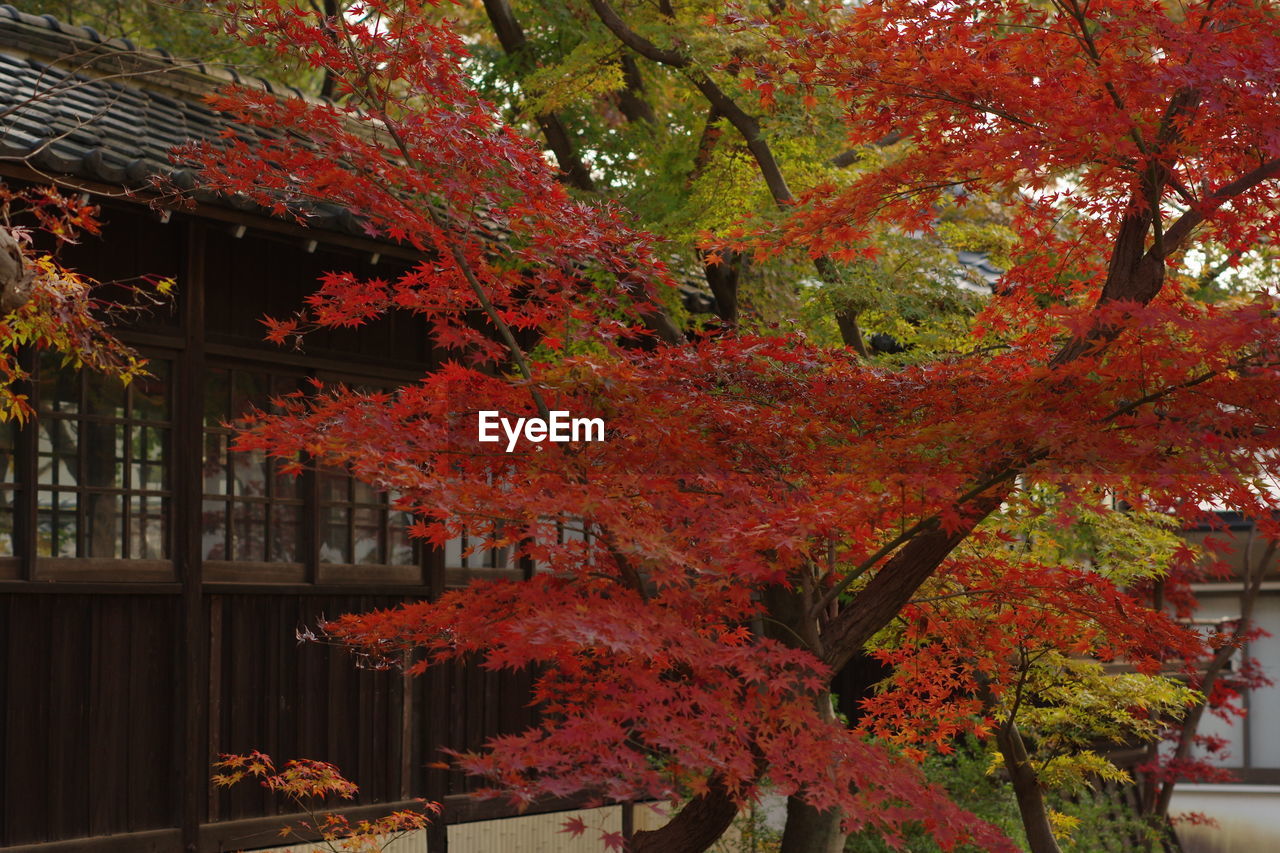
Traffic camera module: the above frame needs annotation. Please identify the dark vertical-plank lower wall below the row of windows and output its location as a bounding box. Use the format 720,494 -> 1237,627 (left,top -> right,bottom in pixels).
0,593 -> 532,850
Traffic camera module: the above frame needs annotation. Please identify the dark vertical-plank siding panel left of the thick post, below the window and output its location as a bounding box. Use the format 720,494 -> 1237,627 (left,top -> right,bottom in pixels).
0,596 -> 177,844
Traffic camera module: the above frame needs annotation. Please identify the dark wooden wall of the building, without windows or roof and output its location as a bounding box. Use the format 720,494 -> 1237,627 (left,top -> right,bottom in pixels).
0,195 -> 545,853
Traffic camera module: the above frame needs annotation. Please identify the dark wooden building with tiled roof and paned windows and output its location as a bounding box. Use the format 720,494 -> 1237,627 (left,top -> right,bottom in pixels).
0,6 -> 563,853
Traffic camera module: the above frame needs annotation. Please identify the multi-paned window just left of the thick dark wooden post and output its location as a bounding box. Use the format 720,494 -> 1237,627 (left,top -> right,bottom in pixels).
34,355 -> 172,560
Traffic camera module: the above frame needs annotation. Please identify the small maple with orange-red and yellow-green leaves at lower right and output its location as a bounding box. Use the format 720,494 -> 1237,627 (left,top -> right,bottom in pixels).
860,489 -> 1203,849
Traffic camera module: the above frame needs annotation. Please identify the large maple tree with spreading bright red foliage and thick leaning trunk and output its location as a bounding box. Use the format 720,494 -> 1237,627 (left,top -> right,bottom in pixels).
160,0 -> 1280,853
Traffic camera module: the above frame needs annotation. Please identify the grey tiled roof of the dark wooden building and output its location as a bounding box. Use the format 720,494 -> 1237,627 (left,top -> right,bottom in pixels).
0,5 -> 362,233
